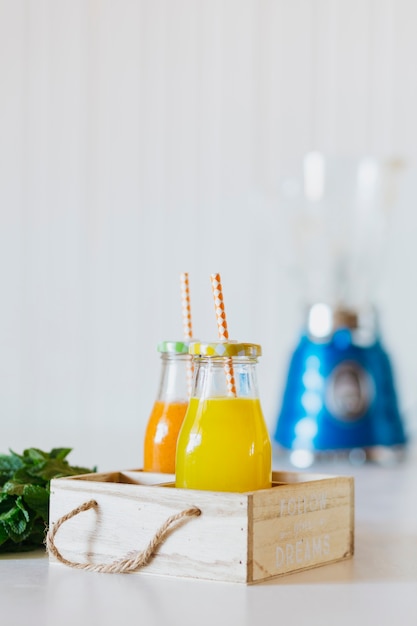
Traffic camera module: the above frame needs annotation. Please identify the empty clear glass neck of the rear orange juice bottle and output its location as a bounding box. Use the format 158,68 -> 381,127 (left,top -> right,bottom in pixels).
157,353 -> 192,402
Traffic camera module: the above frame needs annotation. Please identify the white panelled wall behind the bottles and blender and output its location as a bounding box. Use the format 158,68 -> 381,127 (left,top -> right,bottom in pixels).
0,0 -> 417,470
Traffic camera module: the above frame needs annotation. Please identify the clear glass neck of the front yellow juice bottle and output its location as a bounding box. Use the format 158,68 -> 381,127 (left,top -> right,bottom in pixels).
192,357 -> 259,399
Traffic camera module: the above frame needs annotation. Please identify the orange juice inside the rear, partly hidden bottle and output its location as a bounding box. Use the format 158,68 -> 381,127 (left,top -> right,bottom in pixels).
143,400 -> 188,474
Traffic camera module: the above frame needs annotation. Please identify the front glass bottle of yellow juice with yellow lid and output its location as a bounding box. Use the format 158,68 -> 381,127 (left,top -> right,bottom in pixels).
175,341 -> 272,492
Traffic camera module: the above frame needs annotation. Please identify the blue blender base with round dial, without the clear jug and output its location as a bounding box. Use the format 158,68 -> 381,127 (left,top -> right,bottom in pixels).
274,304 -> 406,467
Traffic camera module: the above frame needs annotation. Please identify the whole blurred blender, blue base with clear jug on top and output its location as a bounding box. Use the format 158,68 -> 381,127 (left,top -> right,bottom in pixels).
274,152 -> 406,467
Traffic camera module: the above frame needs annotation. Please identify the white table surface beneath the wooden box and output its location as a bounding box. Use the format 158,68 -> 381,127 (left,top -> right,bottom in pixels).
0,452 -> 417,626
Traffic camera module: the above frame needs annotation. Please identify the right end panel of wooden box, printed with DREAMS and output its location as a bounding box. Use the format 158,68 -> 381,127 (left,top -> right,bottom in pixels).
248,475 -> 354,582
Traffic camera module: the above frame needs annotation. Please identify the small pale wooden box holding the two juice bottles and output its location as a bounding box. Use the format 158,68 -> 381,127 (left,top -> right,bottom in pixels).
49,470 -> 354,583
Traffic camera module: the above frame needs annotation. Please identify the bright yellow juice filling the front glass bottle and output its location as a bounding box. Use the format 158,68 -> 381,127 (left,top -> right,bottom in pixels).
175,397 -> 272,492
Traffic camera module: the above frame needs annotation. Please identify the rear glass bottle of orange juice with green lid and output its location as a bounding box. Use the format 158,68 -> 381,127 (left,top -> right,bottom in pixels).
143,341 -> 191,474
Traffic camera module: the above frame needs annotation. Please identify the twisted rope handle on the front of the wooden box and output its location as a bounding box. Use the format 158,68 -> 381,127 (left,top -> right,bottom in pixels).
45,500 -> 201,574
